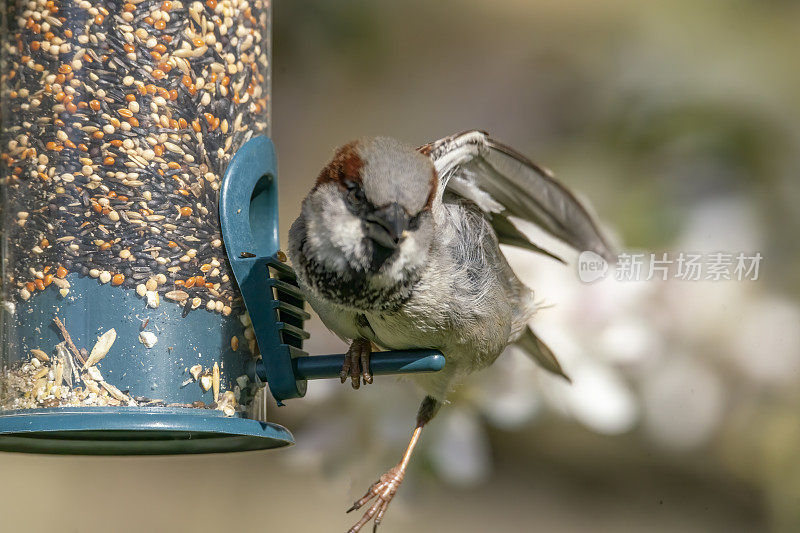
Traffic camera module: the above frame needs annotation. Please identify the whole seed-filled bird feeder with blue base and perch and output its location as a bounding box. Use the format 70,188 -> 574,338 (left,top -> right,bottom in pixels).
0,0 -> 444,454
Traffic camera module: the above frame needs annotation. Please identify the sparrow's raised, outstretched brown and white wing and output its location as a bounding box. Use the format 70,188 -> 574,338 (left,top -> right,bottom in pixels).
419,130 -> 613,262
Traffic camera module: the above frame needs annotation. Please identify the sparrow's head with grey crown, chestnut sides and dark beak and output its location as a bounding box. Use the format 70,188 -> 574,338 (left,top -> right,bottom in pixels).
295,137 -> 438,310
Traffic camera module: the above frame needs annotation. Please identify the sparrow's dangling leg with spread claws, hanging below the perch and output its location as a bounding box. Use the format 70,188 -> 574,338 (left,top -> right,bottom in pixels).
347,396 -> 442,533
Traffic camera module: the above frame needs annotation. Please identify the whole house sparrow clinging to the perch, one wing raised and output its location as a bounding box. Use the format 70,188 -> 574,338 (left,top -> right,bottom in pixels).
289,131 -> 611,533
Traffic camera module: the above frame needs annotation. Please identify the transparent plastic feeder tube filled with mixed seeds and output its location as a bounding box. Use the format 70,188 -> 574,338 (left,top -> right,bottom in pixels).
0,0 -> 270,416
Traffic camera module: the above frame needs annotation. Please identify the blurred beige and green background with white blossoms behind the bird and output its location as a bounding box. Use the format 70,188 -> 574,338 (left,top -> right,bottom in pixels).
0,0 -> 800,533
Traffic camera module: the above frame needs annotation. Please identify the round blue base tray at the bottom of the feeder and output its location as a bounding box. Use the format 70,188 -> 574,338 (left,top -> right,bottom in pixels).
0,407 -> 294,455
